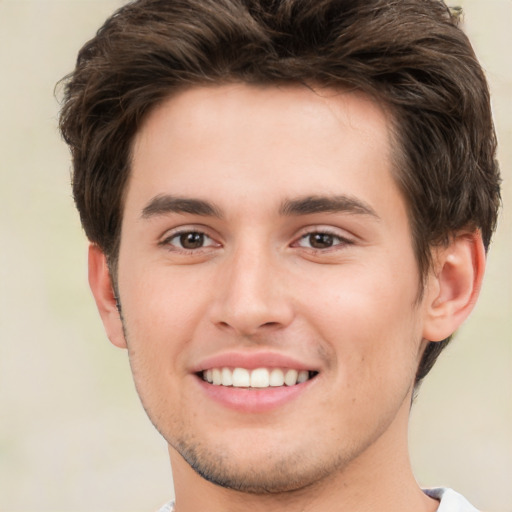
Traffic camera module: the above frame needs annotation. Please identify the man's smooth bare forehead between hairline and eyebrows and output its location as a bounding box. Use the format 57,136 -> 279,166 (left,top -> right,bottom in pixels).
127,84 -> 396,218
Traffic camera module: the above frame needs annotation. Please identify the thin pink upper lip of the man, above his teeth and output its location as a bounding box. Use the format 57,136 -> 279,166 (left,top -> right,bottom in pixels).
192,351 -> 318,373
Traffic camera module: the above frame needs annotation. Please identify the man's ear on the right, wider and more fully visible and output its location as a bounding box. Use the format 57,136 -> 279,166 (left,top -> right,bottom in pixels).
423,230 -> 485,341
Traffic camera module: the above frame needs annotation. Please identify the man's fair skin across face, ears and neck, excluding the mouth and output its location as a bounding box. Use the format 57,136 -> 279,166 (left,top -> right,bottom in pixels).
89,84 -> 484,512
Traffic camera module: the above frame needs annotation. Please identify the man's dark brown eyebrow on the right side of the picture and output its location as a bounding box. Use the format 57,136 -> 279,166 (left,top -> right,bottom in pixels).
279,195 -> 380,219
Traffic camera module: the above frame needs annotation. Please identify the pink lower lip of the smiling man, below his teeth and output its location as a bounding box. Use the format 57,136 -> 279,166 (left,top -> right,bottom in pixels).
197,377 -> 315,413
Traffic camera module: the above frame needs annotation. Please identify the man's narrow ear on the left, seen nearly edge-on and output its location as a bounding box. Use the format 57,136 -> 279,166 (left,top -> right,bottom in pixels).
89,244 -> 126,348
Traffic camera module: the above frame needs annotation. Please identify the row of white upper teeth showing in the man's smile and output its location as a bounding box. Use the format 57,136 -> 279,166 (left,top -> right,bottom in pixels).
202,368 -> 310,388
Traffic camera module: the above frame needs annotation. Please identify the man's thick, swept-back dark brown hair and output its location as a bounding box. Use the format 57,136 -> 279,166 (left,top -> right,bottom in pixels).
60,0 -> 500,382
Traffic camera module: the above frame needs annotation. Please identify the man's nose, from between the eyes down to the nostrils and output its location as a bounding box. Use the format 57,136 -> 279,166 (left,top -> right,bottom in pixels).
211,246 -> 294,337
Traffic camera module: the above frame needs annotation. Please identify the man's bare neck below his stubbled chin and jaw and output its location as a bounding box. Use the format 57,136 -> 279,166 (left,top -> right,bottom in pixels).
169,400 -> 439,512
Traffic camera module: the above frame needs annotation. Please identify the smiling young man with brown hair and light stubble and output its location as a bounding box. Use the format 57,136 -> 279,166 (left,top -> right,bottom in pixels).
61,0 -> 499,512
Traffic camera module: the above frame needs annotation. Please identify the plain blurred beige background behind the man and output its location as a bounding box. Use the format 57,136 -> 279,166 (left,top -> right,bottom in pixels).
0,0 -> 512,512
